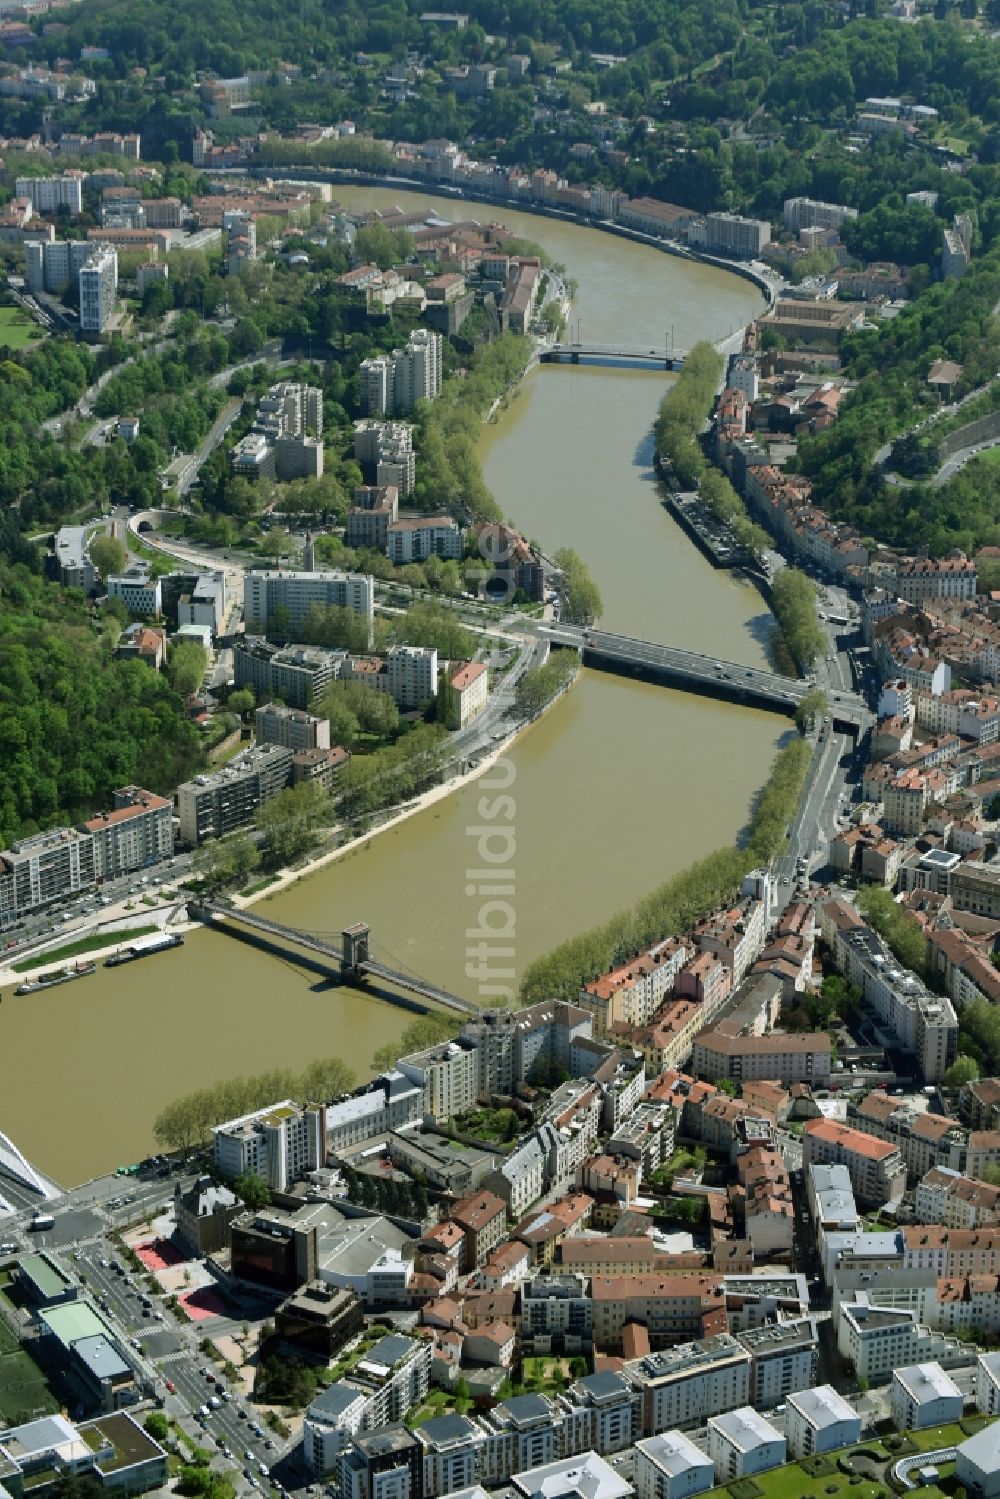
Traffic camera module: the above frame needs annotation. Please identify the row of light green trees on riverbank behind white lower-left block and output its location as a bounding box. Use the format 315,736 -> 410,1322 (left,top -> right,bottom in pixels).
153,1057 -> 355,1150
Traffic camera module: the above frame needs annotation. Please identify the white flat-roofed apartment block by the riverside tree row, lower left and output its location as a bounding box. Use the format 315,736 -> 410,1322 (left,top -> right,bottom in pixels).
211,1099 -> 327,1192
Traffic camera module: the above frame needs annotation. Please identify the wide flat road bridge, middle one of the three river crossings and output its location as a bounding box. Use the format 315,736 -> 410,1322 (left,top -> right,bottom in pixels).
538,625 -> 873,735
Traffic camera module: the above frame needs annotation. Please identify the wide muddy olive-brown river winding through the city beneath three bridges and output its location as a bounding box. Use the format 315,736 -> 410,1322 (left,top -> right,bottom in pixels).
0,189 -> 787,1183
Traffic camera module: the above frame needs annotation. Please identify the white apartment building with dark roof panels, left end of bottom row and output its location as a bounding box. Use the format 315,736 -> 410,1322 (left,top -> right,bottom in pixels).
301,1333 -> 432,1475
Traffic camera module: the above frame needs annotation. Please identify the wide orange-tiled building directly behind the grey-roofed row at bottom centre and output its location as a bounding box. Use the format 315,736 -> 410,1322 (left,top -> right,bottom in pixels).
591,1271 -> 729,1352
